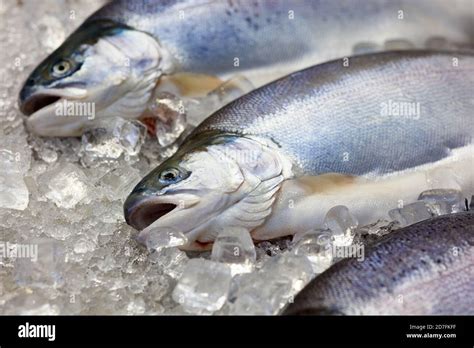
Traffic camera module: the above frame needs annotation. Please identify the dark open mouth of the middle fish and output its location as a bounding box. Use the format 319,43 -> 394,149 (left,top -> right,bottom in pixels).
125,202 -> 177,231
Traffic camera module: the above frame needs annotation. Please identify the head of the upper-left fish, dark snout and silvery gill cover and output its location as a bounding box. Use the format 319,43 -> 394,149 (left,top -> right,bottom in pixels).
19,20 -> 172,136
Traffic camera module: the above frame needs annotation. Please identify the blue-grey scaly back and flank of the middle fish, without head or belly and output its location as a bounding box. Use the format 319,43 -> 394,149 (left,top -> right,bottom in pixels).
194,51 -> 474,175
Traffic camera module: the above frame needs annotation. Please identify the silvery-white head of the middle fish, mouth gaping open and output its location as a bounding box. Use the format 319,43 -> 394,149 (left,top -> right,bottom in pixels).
124,136 -> 290,250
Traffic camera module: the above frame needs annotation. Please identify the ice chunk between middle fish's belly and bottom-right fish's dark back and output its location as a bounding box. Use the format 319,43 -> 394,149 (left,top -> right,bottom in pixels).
293,229 -> 334,274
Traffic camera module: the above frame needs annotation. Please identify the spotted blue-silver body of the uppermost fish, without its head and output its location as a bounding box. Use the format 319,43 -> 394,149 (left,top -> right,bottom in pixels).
85,0 -> 472,82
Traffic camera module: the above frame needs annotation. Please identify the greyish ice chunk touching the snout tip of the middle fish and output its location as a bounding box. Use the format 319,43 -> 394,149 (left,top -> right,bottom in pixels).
99,166 -> 141,201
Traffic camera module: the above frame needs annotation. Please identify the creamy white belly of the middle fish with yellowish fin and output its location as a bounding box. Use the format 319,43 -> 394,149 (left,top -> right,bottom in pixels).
252,145 -> 474,240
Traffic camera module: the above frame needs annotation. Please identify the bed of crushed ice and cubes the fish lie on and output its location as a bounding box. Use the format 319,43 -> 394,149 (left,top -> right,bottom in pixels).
0,0 -> 470,314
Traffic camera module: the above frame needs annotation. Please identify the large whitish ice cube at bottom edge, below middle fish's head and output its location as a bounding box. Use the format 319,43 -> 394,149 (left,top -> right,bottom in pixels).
172,259 -> 232,314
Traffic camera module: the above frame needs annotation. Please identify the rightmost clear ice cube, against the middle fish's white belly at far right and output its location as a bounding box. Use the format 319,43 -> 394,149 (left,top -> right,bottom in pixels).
418,189 -> 466,215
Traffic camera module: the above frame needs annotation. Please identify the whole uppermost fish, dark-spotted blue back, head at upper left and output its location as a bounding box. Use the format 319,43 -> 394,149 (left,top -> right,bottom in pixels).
19,0 -> 474,137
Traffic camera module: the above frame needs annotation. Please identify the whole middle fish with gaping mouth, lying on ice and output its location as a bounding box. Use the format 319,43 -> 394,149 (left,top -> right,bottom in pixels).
124,50 -> 474,250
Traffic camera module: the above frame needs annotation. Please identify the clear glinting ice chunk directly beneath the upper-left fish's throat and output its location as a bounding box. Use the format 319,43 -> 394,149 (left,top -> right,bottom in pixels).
80,117 -> 146,167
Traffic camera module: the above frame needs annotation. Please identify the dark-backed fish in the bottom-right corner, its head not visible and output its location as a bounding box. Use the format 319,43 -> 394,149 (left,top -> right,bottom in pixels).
282,211 -> 474,315
